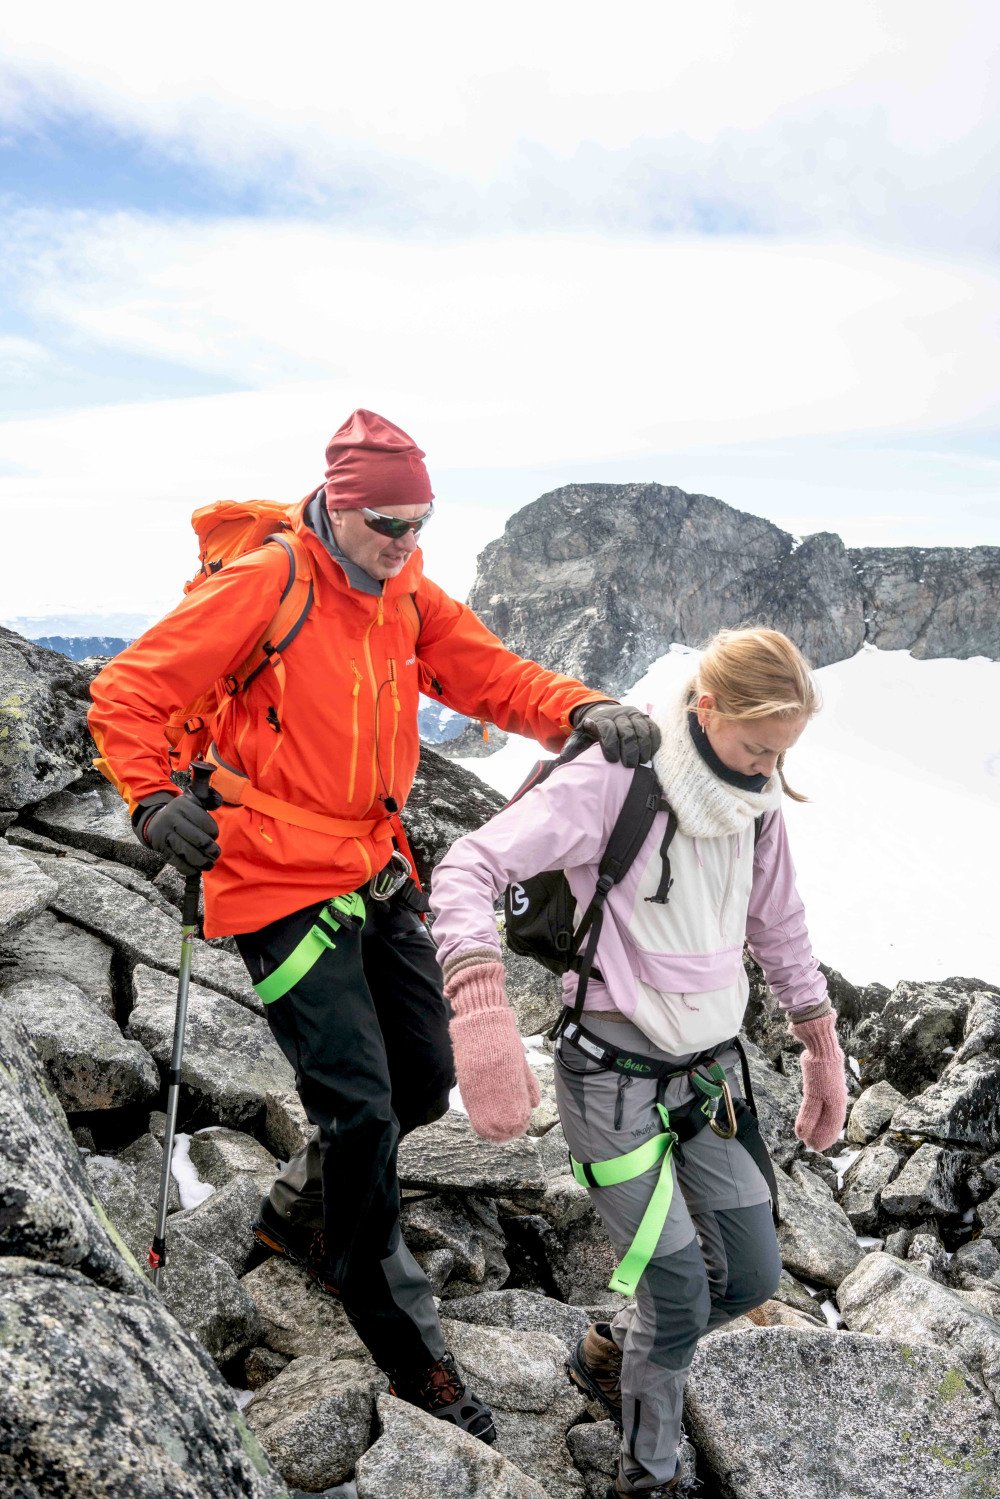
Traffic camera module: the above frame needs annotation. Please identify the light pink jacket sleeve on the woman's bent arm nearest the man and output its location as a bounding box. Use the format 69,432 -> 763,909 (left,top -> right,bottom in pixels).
430,745 -> 631,965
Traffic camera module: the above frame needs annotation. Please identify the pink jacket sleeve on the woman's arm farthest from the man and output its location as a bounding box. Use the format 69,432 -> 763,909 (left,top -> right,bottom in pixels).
747,811 -> 826,1019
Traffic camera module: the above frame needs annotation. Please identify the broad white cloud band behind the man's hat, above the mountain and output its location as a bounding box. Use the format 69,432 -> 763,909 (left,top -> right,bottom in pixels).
0,216 -> 1000,615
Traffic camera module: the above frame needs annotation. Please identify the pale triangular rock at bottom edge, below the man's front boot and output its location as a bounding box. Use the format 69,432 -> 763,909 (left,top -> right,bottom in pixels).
357,1396 -> 546,1499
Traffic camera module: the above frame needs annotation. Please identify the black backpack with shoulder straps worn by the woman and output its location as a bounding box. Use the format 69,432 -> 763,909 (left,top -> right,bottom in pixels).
504,735 -> 678,1039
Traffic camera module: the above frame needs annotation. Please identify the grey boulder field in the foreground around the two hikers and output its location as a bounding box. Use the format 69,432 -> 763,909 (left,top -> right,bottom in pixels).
0,626 -> 1000,1499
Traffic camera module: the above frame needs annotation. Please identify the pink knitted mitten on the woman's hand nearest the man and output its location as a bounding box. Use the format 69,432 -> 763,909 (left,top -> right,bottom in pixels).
444,962 -> 540,1141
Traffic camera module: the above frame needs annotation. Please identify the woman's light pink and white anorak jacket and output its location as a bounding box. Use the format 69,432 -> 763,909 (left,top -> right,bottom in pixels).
430,747 -> 826,1054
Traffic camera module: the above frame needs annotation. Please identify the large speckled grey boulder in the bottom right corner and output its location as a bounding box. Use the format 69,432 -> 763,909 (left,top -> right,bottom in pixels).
685,1325 -> 1000,1499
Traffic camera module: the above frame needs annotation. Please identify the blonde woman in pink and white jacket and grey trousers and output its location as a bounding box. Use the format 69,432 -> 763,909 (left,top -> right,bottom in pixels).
432,630 -> 847,1499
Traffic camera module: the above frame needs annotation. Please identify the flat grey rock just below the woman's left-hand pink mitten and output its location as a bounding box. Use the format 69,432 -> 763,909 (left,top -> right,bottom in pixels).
399,1109 -> 546,1199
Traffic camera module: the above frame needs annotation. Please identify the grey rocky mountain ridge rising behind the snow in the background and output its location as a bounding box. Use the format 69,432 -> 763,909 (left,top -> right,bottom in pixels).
469,484 -> 1000,694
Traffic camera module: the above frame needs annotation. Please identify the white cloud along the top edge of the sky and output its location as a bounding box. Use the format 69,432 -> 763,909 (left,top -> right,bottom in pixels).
0,0 -> 1000,250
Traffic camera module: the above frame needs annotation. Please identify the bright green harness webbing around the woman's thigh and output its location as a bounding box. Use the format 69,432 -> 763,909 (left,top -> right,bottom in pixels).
570,1061 -> 726,1297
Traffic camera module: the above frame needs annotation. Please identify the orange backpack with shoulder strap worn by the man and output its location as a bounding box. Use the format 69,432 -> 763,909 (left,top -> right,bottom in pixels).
165,499 -> 313,770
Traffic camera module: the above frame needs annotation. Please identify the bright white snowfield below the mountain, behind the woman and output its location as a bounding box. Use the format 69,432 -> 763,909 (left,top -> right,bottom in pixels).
459,646 -> 1000,985
